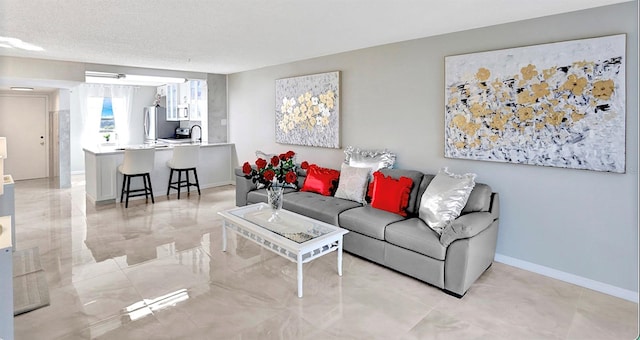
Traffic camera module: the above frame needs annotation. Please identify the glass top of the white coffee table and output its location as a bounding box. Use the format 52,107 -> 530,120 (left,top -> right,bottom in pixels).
229,204 -> 338,243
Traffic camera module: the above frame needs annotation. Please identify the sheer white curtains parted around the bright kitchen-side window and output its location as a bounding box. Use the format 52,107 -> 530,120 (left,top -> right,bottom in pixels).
78,84 -> 134,147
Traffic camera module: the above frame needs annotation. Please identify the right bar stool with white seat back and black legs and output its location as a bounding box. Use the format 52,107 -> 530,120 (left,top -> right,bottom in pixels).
167,145 -> 200,199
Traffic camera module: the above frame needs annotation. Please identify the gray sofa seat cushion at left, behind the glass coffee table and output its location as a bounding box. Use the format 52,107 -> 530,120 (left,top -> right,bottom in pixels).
282,191 -> 362,226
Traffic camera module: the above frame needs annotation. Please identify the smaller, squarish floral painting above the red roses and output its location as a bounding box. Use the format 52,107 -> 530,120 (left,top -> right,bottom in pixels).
275,71 -> 340,148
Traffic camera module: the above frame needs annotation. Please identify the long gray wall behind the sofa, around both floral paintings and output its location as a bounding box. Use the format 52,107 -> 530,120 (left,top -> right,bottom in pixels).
228,2 -> 638,296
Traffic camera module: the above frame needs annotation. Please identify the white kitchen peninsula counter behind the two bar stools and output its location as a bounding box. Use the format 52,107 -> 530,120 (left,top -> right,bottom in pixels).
83,142 -> 235,205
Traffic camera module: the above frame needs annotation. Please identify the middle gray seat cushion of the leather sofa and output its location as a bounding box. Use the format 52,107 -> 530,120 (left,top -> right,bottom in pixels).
338,205 -> 404,241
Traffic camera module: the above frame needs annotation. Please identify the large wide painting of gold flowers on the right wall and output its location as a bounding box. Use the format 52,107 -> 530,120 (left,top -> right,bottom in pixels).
445,35 -> 626,173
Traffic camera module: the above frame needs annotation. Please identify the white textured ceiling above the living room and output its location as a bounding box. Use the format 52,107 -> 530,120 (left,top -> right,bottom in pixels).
0,0 -> 629,76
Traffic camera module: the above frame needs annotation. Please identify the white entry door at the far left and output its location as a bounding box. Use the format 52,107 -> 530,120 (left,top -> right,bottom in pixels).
0,95 -> 49,180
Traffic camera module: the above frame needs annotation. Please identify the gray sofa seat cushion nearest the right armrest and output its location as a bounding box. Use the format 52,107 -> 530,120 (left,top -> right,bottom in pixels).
384,217 -> 447,261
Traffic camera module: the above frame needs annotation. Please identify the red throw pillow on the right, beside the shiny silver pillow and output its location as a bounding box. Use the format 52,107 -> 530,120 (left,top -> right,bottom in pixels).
371,171 -> 413,216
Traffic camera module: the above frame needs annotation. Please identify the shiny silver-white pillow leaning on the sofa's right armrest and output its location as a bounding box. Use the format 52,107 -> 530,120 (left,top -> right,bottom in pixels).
418,167 -> 476,235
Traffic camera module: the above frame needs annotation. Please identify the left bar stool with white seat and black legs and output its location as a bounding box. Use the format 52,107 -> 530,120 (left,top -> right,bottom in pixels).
118,148 -> 156,208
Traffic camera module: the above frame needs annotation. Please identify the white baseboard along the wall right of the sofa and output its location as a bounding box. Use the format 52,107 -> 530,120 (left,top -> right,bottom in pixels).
494,254 -> 638,303
